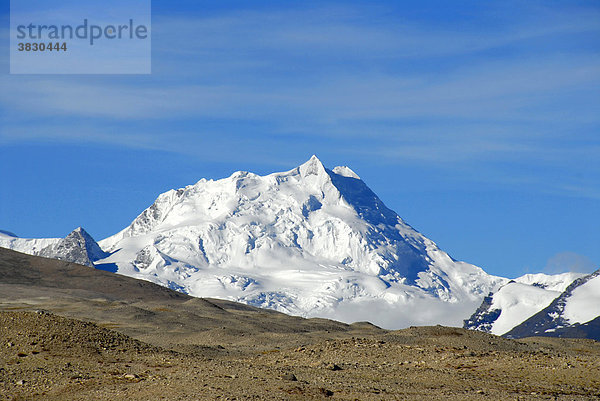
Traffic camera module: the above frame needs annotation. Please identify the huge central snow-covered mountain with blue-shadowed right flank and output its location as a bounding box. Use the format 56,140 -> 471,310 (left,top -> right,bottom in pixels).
96,156 -> 508,328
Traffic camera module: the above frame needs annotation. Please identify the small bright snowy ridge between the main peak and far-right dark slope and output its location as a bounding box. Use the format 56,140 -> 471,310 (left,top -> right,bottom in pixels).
463,273 -> 585,335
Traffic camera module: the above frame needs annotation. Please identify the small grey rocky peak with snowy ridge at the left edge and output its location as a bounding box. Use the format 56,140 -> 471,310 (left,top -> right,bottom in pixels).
0,227 -> 108,267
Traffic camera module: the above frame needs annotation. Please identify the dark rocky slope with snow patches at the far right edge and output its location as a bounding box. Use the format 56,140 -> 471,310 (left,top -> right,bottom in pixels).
506,270 -> 600,341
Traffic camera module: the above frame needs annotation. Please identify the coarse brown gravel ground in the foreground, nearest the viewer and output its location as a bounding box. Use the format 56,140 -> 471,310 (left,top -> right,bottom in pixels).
0,312 -> 600,400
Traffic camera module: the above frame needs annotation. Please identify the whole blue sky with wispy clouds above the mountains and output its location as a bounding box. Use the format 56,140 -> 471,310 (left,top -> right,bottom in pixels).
0,0 -> 600,276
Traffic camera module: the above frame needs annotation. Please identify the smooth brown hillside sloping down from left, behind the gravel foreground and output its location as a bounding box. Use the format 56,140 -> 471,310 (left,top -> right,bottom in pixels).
0,248 -> 382,346
